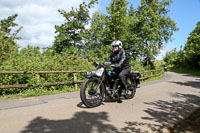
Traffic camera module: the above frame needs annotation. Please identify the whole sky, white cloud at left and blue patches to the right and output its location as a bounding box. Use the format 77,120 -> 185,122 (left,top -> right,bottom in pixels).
0,0 -> 200,59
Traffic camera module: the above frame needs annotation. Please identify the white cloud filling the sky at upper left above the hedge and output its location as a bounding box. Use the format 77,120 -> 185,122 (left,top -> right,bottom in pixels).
0,0 -> 86,48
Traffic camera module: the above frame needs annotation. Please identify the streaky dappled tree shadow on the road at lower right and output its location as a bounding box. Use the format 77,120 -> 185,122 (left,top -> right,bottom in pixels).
122,93 -> 200,133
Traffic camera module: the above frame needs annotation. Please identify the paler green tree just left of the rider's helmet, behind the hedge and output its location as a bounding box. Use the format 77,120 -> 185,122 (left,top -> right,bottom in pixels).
84,11 -> 111,61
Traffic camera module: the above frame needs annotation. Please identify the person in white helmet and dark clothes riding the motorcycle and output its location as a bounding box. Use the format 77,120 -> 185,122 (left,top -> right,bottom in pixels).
106,40 -> 131,102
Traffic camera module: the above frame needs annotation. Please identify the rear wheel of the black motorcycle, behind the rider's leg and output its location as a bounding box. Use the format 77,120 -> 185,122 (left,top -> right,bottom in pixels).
124,77 -> 136,99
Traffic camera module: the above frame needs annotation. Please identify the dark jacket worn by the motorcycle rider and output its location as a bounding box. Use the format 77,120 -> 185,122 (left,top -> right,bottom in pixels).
106,49 -> 130,71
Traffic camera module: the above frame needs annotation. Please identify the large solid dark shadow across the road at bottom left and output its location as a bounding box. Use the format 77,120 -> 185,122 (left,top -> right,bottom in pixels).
21,111 -> 117,133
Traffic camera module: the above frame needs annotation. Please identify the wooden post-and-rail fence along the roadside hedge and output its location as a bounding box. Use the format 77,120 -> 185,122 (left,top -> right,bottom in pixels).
0,69 -> 163,89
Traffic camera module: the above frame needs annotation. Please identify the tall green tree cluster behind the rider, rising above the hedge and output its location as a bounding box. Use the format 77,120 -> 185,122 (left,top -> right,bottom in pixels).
54,0 -> 178,65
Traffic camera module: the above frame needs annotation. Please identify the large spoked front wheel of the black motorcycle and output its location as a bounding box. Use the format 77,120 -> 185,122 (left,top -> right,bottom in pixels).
80,77 -> 104,108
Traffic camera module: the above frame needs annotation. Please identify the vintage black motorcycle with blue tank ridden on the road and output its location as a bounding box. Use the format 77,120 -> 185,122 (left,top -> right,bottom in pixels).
80,62 -> 140,108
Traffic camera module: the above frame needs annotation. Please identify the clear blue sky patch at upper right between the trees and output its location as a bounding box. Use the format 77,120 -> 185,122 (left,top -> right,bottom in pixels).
163,0 -> 200,57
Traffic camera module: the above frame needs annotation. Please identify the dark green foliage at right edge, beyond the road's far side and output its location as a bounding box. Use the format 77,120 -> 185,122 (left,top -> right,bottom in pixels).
164,22 -> 200,69
